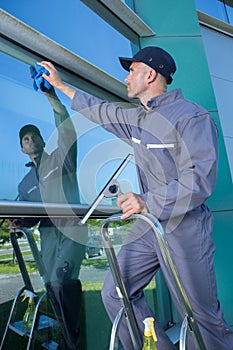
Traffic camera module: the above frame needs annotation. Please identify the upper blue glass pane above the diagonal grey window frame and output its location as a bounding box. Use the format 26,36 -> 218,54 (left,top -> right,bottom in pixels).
1,0 -> 131,81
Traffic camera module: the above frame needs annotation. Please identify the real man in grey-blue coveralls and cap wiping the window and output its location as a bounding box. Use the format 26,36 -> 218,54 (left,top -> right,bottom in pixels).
37,47 -> 233,350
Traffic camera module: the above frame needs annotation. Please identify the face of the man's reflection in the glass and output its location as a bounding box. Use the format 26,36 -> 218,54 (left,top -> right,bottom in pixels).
22,132 -> 44,156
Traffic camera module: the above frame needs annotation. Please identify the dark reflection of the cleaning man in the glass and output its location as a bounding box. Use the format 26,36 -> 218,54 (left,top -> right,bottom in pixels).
10,88 -> 86,350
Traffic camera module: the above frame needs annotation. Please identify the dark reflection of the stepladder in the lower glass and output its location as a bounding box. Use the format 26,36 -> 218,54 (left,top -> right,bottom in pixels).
0,228 -> 59,350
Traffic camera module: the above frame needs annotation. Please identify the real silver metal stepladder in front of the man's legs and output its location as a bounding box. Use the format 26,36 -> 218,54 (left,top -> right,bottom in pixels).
101,214 -> 206,350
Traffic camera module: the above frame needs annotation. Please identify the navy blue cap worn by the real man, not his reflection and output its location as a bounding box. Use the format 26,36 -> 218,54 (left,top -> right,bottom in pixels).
119,46 -> 176,84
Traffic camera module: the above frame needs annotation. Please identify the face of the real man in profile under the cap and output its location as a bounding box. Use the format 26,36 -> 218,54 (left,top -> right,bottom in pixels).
125,62 -> 150,100
